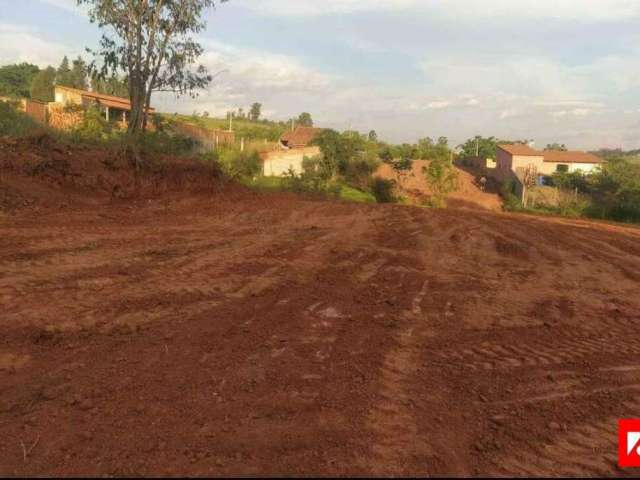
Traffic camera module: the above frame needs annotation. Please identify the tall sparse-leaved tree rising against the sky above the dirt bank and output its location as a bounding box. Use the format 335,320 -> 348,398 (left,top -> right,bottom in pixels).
77,0 -> 227,133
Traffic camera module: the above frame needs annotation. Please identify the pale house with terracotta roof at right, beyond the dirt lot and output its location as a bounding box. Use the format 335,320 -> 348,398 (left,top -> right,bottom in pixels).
496,144 -> 605,177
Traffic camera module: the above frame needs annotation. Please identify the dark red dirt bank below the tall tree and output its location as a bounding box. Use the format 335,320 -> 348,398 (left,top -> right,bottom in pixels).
0,133 -> 222,210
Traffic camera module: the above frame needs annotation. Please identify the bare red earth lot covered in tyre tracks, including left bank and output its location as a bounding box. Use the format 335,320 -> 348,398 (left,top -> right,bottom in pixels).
0,141 -> 640,476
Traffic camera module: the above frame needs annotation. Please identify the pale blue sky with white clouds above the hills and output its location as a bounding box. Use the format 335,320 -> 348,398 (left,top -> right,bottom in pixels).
0,0 -> 640,148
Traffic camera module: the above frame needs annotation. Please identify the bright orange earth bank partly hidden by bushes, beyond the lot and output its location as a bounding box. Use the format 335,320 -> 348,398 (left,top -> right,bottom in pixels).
376,160 -> 502,212
